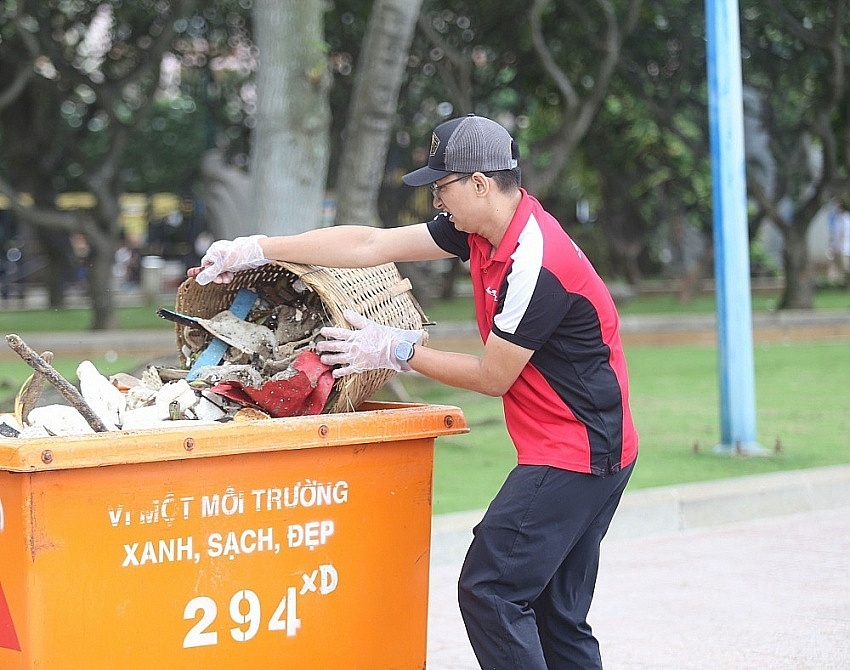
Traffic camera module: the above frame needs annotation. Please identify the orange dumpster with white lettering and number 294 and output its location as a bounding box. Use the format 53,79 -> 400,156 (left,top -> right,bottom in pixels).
0,403 -> 467,670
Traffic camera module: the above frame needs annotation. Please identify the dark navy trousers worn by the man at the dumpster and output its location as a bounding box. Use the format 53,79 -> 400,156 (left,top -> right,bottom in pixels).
458,465 -> 634,670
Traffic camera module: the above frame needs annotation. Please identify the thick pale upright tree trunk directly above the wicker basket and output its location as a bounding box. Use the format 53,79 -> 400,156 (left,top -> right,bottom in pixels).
251,0 -> 330,235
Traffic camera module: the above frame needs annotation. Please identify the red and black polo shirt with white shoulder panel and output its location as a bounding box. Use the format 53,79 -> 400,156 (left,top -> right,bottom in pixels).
428,189 -> 638,475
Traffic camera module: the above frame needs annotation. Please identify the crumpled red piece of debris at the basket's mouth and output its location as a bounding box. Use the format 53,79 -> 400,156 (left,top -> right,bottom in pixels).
211,351 -> 334,419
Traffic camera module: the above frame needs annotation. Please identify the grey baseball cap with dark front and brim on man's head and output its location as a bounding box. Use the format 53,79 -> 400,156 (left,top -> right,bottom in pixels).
401,114 -> 519,186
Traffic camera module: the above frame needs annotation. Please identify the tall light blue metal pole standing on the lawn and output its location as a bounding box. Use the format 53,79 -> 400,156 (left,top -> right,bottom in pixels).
706,0 -> 765,453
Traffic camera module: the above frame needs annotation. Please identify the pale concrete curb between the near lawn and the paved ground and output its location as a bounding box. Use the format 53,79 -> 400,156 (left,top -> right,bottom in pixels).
431,465 -> 850,565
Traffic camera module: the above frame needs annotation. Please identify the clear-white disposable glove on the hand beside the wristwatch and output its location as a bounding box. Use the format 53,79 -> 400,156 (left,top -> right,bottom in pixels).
316,309 -> 425,377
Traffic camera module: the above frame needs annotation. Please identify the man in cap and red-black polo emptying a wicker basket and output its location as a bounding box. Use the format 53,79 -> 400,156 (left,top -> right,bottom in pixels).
189,115 -> 637,670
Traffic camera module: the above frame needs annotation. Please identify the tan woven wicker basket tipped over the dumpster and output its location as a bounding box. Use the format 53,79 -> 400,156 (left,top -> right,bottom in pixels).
175,262 -> 427,413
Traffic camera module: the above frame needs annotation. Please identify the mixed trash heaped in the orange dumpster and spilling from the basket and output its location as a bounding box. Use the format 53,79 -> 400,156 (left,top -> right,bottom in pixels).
0,276 -> 334,437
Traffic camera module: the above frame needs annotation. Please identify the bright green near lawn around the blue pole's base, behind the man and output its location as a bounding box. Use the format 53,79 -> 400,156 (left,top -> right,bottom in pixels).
384,342 -> 850,513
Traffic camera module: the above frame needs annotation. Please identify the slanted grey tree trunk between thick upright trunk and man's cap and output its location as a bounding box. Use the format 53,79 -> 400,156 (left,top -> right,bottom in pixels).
336,0 -> 422,225
